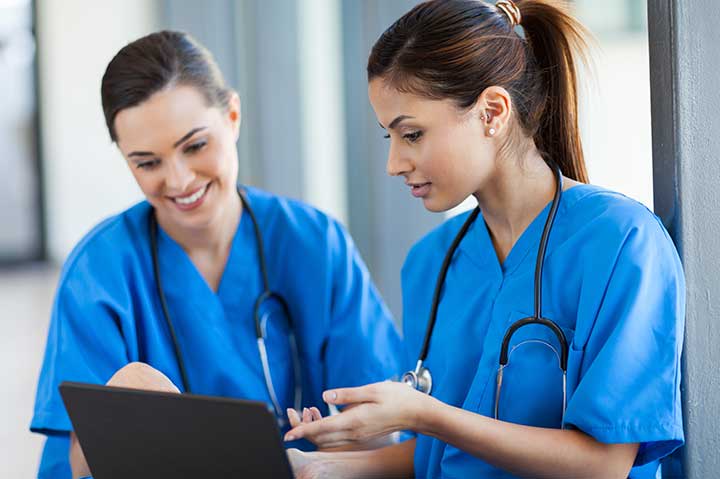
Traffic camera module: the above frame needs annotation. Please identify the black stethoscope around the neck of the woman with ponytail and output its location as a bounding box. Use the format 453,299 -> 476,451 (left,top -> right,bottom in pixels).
402,165 -> 568,420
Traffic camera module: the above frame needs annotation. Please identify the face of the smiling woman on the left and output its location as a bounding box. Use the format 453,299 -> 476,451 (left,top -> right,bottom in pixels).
114,84 -> 240,272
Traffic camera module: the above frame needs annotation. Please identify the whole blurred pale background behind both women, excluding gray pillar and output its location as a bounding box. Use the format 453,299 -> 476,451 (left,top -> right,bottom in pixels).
0,0 -> 653,477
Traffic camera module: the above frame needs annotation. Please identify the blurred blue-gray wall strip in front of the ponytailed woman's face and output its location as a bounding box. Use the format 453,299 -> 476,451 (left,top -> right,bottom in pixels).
342,0 -> 444,319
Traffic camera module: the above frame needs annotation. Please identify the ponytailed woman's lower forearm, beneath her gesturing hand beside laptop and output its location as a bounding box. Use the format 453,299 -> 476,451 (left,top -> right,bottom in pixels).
312,439 -> 415,479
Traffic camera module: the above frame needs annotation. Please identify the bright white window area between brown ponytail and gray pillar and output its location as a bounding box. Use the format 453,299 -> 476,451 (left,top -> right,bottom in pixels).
575,0 -> 653,209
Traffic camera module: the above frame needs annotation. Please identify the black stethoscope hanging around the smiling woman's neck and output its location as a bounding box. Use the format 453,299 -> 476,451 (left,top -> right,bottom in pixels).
149,187 -> 302,427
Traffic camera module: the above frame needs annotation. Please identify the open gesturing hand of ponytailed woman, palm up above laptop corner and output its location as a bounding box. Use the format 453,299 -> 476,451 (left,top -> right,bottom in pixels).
285,381 -> 430,448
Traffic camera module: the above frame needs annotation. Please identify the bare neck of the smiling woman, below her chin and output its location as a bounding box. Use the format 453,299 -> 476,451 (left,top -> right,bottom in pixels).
157,191 -> 242,257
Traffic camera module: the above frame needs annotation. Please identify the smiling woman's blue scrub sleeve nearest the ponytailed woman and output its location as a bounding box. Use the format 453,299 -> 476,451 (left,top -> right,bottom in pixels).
325,221 -> 401,388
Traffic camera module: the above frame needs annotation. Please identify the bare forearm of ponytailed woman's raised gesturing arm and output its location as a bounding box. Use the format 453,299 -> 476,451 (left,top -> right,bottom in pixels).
414,398 -> 637,479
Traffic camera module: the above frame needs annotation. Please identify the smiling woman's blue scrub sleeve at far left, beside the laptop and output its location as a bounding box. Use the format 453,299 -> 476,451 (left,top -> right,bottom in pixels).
30,256 -> 129,434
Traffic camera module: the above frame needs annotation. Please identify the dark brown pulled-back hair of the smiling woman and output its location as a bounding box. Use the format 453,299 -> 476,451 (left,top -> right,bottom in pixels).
100,31 -> 232,142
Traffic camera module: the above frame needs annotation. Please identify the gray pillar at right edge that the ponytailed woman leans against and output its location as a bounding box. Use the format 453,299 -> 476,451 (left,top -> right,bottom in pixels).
648,0 -> 720,479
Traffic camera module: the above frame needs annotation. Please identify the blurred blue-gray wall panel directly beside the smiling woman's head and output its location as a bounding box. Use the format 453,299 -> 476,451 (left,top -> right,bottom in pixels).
161,0 -> 303,198
